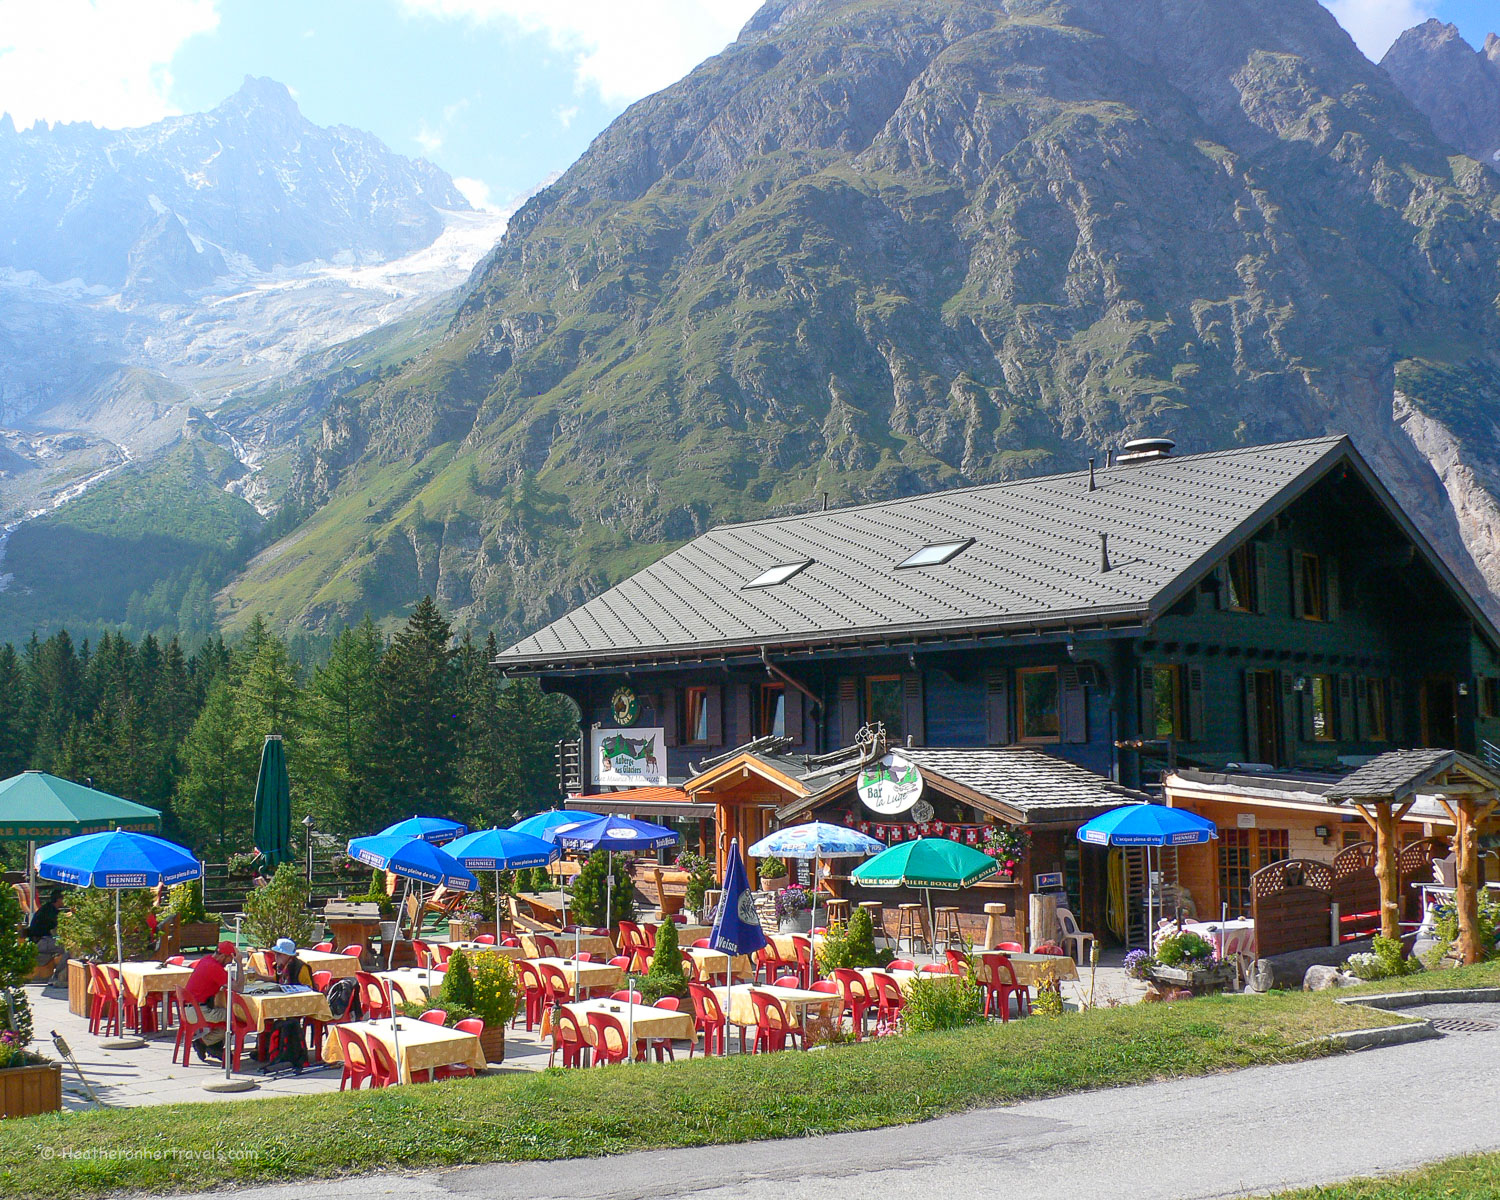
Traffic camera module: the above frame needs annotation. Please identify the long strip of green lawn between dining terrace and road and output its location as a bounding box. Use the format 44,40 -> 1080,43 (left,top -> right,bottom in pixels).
0,975 -> 1404,1197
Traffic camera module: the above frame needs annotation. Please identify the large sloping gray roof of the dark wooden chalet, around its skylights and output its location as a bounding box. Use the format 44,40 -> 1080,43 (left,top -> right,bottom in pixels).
497,437 -> 1386,668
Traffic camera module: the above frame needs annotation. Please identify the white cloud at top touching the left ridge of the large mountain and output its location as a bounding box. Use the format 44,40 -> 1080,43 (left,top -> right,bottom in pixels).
402,0 -> 761,105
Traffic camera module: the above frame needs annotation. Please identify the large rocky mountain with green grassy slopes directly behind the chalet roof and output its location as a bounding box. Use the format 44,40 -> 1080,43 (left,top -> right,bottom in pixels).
221,0 -> 1500,633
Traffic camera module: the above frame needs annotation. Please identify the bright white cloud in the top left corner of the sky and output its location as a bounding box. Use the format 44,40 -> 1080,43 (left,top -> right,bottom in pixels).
0,0 -> 219,128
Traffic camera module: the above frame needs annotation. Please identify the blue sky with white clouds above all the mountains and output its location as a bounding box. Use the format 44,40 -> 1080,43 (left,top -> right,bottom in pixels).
0,0 -> 1500,204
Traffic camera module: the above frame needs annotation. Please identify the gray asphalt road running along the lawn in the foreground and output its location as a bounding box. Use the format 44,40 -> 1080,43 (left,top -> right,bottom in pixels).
170,1005 -> 1500,1200
